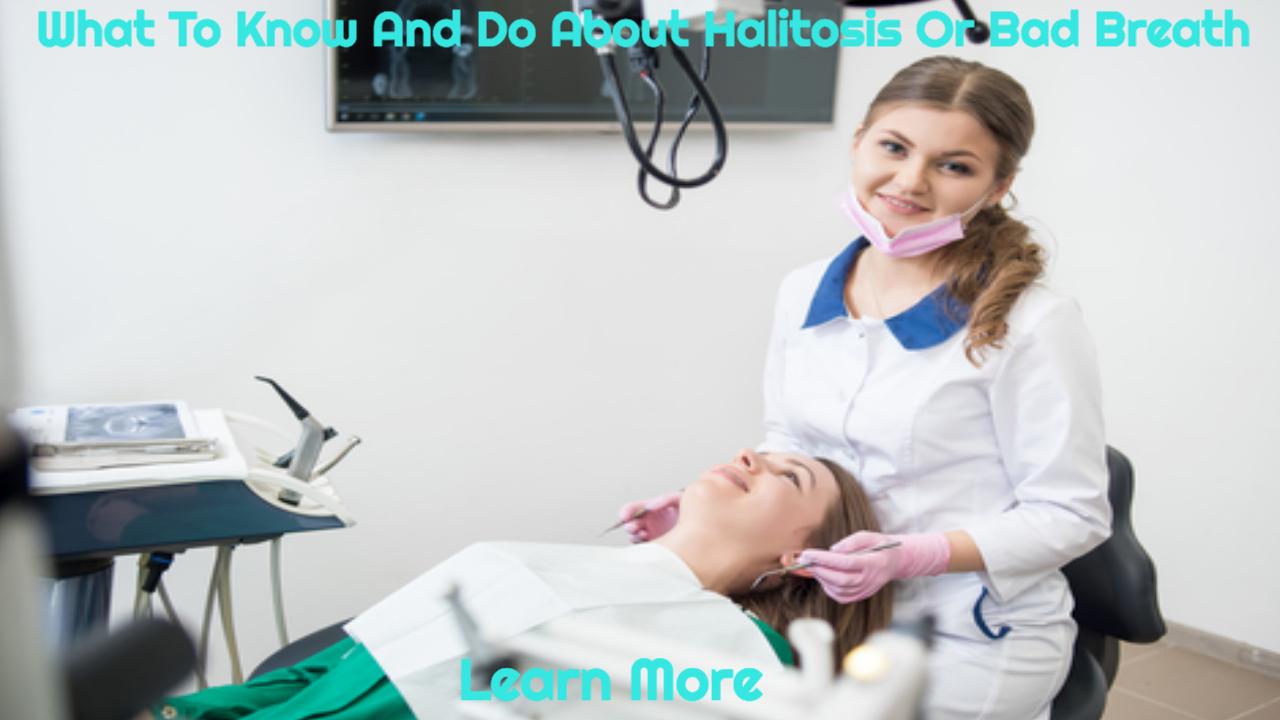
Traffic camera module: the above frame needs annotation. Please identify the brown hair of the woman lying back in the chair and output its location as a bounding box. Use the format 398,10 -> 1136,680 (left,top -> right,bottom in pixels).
733,457 -> 893,667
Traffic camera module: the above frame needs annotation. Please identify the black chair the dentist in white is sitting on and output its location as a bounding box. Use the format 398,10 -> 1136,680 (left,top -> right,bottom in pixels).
1050,446 -> 1165,720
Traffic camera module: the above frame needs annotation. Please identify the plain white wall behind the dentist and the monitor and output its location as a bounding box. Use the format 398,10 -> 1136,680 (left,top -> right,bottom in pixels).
0,0 -> 1280,681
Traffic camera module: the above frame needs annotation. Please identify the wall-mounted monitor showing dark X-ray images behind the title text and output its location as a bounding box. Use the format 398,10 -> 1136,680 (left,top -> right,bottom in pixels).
326,0 -> 841,131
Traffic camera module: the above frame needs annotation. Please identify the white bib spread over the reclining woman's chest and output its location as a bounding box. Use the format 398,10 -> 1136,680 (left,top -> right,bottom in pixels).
346,542 -> 780,717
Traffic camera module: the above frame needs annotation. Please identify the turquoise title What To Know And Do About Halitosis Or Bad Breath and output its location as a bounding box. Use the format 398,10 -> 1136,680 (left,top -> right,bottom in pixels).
37,8 -> 1249,49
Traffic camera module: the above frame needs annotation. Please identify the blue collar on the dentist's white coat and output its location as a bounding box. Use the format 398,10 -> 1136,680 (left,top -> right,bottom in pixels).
804,237 -> 969,350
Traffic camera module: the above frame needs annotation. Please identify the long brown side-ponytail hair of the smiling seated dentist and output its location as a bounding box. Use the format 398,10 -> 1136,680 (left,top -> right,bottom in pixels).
863,55 -> 1044,365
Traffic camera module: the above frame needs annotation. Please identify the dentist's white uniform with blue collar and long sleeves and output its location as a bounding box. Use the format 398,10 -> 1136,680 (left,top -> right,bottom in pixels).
762,240 -> 1111,720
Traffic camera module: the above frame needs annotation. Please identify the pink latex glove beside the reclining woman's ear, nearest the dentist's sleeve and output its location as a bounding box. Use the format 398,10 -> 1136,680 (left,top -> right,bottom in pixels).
797,532 -> 951,602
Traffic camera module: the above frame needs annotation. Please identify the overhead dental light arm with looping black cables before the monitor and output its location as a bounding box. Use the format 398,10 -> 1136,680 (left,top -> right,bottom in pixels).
586,0 -> 991,210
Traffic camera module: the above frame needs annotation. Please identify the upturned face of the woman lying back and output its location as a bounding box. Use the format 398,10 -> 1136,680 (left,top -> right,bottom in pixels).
680,450 -> 840,561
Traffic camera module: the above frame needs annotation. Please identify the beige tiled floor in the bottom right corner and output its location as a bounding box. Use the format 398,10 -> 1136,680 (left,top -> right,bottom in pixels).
1102,643 -> 1280,720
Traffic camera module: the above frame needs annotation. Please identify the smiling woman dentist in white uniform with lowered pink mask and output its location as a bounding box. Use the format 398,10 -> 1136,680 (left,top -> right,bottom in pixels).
622,56 -> 1111,720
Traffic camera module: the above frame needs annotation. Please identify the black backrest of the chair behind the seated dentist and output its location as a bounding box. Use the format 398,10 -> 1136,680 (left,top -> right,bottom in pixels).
1062,446 -> 1165,643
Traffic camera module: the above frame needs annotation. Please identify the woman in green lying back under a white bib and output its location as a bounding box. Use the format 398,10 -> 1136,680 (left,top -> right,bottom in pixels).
152,450 -> 891,720
